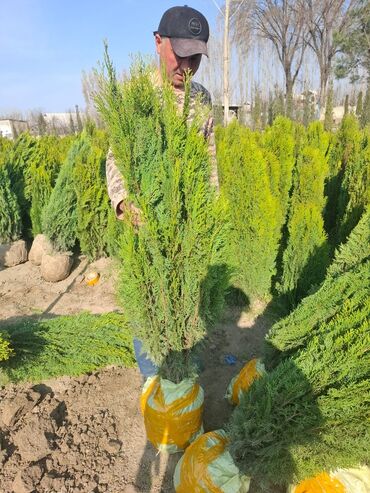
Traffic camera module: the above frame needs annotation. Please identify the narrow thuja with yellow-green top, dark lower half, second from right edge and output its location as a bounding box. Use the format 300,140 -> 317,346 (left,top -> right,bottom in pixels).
324,115 -> 362,242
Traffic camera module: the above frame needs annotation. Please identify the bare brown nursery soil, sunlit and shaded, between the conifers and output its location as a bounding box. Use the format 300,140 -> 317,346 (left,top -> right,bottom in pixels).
0,258 -> 277,493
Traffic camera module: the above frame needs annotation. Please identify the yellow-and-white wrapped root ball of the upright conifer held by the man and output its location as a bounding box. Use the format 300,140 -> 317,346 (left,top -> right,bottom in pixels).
141,376 -> 204,454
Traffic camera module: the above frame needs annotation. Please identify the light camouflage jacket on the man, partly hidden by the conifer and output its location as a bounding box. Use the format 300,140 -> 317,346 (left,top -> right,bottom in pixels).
106,81 -> 219,218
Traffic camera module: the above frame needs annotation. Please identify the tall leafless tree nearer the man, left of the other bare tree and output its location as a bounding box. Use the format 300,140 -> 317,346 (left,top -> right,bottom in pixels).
253,0 -> 307,116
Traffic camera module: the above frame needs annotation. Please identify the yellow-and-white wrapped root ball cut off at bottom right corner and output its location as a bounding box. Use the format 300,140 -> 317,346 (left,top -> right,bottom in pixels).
288,466 -> 370,493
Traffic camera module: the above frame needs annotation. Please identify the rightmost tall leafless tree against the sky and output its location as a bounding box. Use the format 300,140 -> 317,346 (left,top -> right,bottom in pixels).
299,0 -> 354,108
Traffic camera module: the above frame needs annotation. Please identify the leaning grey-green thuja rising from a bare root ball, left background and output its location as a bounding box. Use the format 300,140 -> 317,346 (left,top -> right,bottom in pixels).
42,137 -> 86,252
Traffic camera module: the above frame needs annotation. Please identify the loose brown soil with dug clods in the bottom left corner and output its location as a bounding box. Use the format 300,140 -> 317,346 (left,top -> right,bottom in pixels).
0,368 -> 178,493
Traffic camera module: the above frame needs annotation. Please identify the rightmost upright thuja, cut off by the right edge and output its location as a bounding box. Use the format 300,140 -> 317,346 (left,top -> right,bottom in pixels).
336,117 -> 370,244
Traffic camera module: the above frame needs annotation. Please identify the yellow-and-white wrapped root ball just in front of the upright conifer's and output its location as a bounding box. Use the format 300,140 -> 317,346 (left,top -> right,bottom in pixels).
174,430 -> 250,493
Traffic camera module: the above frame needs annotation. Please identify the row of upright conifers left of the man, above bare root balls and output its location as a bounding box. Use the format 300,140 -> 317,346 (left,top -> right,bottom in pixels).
0,124 -> 121,260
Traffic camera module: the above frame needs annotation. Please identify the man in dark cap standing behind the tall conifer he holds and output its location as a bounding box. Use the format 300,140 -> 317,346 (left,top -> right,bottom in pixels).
106,6 -> 219,377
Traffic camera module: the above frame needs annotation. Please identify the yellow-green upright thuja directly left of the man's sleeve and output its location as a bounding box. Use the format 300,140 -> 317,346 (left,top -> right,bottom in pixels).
73,123 -> 110,260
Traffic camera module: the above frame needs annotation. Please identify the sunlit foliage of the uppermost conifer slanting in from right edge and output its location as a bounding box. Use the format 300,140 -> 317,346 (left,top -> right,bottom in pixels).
266,211 -> 370,361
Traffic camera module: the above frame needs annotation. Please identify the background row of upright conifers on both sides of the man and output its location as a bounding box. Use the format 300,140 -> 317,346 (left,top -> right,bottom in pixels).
0,115 -> 370,306
